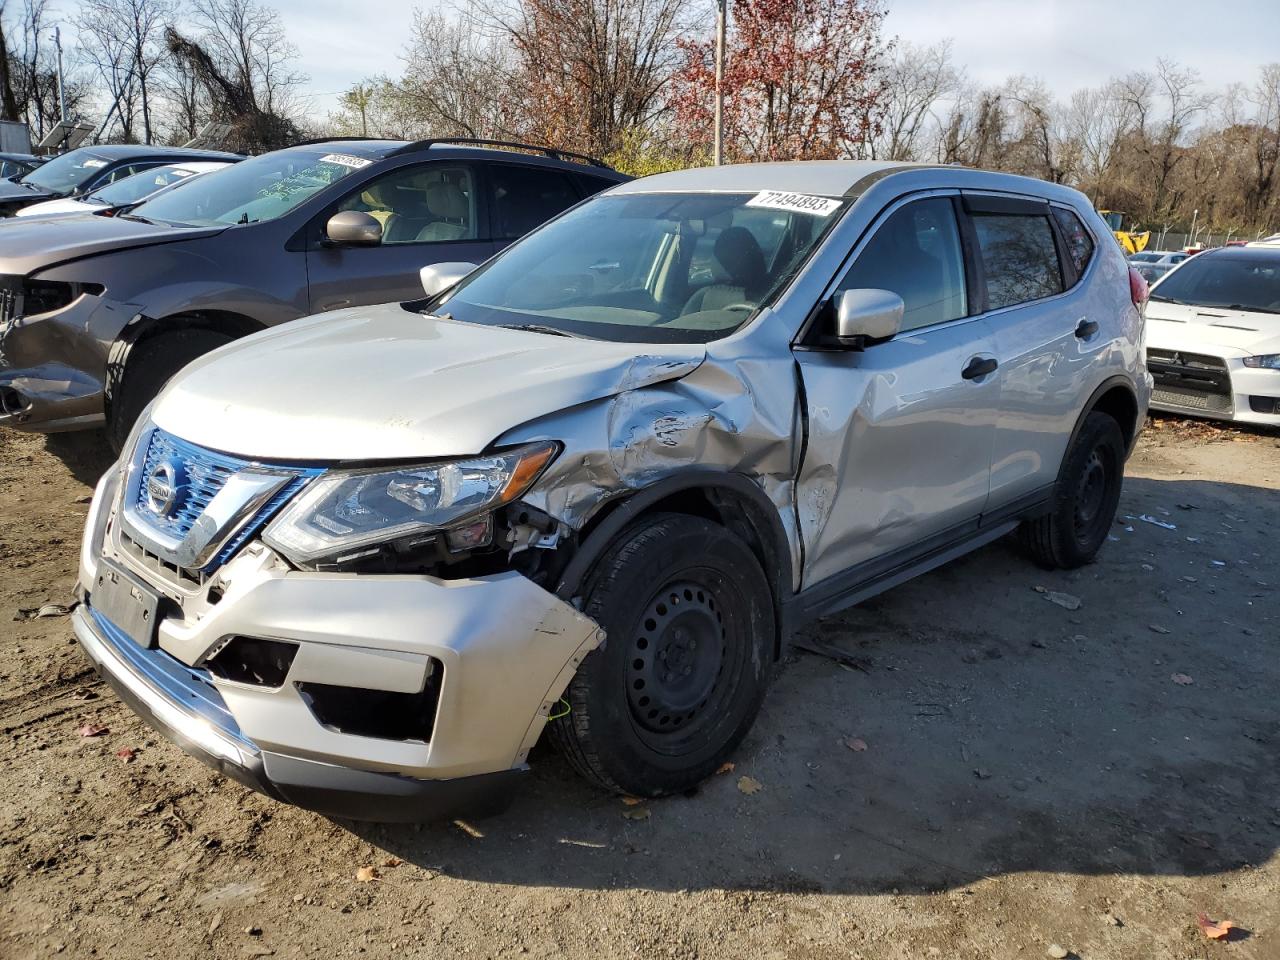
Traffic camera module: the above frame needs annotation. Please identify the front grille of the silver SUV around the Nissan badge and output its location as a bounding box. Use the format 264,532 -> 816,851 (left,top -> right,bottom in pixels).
120,429 -> 323,578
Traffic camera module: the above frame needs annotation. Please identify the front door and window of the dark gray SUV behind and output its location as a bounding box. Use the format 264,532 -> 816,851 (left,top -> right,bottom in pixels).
306,160 -> 494,314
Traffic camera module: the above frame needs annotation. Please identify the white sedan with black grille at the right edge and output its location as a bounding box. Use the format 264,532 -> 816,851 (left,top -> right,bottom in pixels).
1147,246 -> 1280,426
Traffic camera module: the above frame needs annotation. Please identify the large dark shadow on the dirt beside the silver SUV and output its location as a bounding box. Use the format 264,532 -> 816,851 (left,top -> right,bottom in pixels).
344,479 -> 1280,892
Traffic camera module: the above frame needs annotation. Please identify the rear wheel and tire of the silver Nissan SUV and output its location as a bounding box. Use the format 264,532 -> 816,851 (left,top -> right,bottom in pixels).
1018,412 -> 1125,570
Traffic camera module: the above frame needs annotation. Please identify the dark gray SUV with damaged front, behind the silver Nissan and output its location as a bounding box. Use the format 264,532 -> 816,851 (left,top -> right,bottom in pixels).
0,140 -> 627,447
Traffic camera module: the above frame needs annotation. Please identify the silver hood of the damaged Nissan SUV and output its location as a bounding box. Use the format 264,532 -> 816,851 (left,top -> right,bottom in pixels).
152,303 -> 707,461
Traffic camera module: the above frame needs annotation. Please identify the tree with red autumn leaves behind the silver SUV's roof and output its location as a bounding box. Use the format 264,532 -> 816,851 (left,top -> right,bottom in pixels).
675,0 -> 887,160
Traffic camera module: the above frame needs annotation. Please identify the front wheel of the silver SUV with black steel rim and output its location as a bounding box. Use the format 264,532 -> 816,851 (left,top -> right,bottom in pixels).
550,513 -> 774,796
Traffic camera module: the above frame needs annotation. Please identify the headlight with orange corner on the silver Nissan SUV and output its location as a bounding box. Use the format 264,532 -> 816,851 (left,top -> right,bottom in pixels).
262,443 -> 558,563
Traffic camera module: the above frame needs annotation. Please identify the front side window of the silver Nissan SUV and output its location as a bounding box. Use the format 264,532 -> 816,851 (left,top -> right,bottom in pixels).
838,197 -> 969,330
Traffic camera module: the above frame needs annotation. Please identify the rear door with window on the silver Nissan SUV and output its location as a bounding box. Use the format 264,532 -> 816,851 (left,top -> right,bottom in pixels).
964,193 -> 1115,512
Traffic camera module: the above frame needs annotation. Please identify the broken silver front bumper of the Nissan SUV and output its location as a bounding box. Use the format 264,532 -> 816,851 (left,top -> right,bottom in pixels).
76,470 -> 602,820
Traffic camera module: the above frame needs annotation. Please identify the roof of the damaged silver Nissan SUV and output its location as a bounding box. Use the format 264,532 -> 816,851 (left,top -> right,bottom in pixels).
609,160 -> 1083,202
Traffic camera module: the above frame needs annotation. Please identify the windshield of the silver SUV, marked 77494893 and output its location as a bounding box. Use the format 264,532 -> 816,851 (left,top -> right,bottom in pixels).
430,191 -> 846,343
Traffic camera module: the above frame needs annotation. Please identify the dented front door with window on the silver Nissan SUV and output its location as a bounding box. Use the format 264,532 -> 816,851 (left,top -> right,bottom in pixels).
795,196 -> 1000,588
